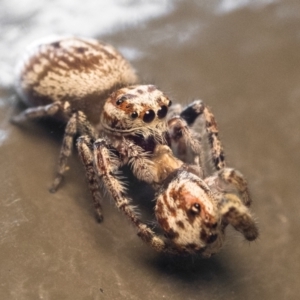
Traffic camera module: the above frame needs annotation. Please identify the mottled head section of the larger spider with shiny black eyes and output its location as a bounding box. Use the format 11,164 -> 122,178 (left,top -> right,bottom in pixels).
100,85 -> 171,140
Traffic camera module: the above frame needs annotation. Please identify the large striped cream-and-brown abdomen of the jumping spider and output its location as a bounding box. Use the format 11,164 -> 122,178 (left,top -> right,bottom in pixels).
16,37 -> 137,124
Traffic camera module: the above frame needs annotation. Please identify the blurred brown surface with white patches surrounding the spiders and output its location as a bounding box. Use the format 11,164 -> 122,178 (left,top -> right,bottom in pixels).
0,0 -> 300,300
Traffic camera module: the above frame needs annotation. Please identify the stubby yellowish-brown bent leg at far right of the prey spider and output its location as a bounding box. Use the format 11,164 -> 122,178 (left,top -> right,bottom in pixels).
219,193 -> 258,241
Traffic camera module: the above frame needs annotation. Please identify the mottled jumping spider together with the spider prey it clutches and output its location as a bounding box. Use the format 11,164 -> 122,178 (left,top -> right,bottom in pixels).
14,38 -> 258,256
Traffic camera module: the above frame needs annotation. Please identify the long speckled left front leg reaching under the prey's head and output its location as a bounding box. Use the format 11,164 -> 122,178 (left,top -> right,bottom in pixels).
94,139 -> 176,253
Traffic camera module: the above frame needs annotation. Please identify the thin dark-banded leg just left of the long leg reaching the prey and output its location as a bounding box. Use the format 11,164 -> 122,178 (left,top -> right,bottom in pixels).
77,136 -> 103,222
